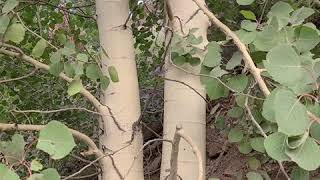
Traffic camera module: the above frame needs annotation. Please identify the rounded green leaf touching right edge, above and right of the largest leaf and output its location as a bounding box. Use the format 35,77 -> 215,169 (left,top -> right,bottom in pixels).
294,26 -> 320,52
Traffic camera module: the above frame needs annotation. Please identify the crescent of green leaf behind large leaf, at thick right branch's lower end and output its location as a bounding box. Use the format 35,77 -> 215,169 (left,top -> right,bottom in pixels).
262,89 -> 279,122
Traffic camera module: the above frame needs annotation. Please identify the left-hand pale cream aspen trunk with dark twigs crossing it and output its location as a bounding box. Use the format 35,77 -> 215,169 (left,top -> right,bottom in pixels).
96,0 -> 144,180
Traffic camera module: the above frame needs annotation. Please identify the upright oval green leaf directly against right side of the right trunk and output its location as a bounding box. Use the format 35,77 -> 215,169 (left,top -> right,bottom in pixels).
202,41 -> 222,67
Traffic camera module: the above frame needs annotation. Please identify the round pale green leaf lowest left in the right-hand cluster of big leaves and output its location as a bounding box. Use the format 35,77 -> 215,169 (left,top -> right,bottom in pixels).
264,132 -> 290,161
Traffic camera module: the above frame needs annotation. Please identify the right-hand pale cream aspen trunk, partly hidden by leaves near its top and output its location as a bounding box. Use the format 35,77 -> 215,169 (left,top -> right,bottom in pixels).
160,0 -> 209,180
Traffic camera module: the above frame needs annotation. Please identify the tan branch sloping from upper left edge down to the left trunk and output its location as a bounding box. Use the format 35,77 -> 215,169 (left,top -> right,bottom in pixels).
0,43 -> 104,112
